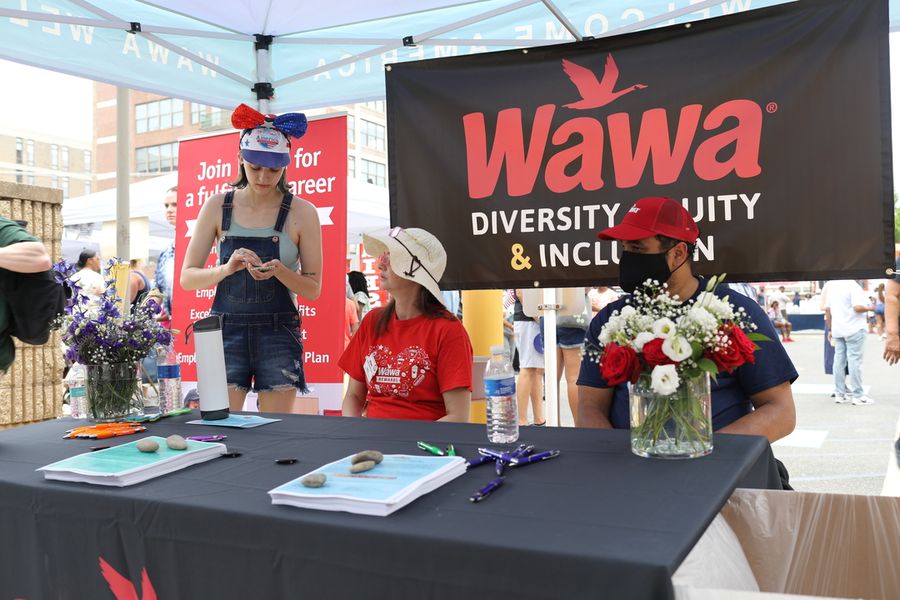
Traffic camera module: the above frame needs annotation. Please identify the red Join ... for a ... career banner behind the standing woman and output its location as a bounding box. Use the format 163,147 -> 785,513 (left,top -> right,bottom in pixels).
172,116 -> 347,388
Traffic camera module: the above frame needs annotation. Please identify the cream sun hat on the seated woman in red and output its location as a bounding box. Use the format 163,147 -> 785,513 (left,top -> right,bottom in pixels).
363,227 -> 447,304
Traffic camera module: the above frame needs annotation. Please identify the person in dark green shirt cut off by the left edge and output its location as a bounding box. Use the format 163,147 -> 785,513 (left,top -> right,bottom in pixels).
0,217 -> 52,375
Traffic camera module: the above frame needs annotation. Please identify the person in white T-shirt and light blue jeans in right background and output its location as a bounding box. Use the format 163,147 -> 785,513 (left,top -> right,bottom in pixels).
825,280 -> 875,406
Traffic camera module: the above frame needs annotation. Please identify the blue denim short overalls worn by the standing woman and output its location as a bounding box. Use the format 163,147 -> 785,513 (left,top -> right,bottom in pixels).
212,191 -> 306,392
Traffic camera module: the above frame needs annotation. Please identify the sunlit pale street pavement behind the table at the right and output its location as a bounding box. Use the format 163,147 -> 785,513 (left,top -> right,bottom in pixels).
548,330 -> 900,496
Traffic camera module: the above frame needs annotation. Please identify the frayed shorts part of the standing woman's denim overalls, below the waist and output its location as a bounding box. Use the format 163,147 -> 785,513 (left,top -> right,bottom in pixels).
213,312 -> 307,392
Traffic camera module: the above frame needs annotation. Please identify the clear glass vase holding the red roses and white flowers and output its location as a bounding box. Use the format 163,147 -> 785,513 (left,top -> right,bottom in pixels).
629,373 -> 713,458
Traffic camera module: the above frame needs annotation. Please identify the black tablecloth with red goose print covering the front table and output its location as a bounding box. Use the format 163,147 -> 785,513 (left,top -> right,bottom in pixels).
0,411 -> 779,600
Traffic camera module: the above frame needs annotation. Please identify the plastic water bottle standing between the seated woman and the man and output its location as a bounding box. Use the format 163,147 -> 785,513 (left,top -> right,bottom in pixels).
484,346 -> 519,444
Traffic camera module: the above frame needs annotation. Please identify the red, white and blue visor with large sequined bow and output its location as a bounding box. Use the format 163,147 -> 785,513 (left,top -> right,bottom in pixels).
231,104 -> 307,169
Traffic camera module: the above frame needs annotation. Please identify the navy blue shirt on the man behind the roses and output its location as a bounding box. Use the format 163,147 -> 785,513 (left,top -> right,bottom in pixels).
578,277 -> 798,430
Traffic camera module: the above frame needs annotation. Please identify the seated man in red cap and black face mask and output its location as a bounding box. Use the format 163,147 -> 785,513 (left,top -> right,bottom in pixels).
577,198 -> 797,468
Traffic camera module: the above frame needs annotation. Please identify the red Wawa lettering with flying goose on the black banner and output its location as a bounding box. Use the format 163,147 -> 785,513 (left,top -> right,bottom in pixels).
463,54 -> 763,199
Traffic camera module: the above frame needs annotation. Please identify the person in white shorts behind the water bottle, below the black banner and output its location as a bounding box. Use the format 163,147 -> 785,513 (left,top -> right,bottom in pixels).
513,289 -> 547,427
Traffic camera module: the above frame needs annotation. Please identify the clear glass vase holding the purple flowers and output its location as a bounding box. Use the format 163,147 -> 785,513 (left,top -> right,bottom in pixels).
85,363 -> 142,423
